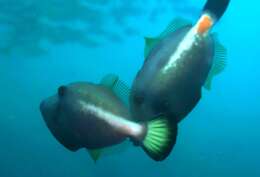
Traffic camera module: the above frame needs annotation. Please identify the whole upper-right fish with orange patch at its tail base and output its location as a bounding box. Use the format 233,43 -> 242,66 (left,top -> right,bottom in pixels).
126,0 -> 230,153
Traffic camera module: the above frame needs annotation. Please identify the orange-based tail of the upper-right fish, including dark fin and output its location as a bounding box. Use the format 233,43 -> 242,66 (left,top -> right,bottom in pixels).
198,0 -> 230,34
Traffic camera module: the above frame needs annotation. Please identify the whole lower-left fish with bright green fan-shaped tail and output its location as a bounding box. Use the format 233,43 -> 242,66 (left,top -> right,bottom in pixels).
40,75 -> 175,161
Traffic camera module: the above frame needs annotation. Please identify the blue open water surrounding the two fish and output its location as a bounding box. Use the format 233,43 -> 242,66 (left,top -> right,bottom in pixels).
0,0 -> 260,177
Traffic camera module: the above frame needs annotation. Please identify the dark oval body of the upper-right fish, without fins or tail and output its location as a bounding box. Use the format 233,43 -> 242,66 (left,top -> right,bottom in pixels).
130,22 -> 214,122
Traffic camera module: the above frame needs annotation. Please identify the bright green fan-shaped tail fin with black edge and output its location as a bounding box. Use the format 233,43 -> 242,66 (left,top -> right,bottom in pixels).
142,117 -> 177,161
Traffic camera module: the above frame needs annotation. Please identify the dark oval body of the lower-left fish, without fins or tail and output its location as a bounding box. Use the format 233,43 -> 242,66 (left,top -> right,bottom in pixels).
40,82 -> 141,150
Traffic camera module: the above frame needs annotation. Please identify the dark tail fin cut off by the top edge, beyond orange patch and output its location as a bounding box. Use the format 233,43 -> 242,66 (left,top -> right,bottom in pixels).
203,0 -> 230,21
